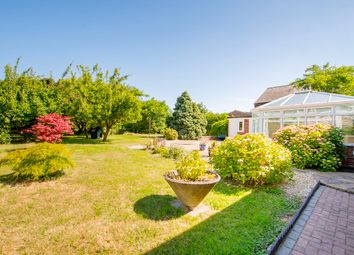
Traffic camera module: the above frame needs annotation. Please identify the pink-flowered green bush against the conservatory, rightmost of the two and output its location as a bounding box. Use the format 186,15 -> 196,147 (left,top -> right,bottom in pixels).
273,124 -> 344,171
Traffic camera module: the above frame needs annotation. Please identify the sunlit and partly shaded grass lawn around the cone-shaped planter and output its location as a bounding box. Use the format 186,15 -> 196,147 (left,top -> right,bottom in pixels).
0,135 -> 299,254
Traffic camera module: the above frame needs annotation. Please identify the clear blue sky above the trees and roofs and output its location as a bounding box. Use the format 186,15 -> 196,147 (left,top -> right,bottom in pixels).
0,0 -> 354,112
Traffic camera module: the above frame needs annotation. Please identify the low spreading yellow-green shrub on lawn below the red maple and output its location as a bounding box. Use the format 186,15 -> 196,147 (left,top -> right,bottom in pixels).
0,143 -> 74,180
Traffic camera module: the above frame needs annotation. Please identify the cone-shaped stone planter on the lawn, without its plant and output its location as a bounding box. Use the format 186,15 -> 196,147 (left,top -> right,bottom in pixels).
164,170 -> 220,211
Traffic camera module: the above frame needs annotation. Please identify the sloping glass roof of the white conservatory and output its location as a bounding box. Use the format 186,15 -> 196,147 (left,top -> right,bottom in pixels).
258,91 -> 354,109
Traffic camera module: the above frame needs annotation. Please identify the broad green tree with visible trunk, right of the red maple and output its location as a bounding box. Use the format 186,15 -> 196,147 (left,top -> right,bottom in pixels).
58,65 -> 143,141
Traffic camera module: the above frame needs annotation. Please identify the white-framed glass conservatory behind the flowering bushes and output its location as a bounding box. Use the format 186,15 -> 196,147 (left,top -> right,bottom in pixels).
252,91 -> 354,145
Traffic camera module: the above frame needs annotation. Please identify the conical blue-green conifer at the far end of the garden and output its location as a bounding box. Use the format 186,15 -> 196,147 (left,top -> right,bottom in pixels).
171,91 -> 207,139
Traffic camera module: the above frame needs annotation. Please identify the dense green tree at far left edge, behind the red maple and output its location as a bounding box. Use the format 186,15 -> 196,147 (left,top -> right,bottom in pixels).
0,59 -> 58,137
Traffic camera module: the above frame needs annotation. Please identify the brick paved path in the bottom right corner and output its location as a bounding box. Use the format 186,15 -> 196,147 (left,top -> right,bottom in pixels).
275,185 -> 354,255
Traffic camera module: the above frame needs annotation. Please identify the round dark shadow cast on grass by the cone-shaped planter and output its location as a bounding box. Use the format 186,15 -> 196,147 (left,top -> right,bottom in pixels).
134,195 -> 184,221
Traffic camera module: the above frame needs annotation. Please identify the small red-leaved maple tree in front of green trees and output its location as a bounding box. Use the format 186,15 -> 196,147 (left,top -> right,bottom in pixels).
24,113 -> 74,143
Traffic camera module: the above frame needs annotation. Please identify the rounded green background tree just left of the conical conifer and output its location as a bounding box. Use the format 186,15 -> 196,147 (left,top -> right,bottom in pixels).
125,98 -> 171,134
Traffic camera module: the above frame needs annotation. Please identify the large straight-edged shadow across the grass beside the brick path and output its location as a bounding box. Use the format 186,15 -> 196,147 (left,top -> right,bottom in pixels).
145,190 -> 295,255
